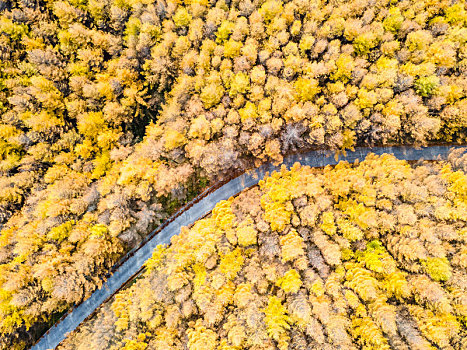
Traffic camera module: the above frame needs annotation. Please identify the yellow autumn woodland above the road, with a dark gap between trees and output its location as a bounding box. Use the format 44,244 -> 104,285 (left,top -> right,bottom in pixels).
0,0 -> 467,349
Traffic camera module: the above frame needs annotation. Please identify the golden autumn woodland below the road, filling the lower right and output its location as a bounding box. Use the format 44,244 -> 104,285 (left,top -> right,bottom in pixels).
58,155 -> 467,350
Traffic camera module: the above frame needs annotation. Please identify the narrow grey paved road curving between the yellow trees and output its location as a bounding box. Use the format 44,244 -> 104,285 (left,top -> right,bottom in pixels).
31,146 -> 460,350
